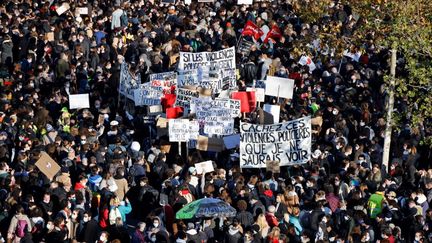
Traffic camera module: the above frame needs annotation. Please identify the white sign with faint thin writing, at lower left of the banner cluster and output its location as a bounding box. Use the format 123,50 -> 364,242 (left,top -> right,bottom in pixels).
168,119 -> 199,142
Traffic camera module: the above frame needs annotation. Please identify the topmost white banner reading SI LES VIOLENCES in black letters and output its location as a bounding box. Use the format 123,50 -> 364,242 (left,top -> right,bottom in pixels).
178,47 -> 236,71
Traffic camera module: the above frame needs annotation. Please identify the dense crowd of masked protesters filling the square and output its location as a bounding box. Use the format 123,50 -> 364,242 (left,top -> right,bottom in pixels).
0,0 -> 432,243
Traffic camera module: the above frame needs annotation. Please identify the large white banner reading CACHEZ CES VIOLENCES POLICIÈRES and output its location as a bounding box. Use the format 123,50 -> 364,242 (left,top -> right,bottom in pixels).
240,116 -> 312,168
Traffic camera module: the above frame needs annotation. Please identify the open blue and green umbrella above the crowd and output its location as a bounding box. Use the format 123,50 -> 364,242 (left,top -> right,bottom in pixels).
176,198 -> 237,219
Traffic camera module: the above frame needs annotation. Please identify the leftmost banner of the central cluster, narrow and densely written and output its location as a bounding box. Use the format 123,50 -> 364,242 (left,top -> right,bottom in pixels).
119,62 -> 141,100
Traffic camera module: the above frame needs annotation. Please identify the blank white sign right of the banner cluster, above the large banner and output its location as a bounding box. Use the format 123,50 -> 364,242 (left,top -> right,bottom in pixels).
265,76 -> 294,99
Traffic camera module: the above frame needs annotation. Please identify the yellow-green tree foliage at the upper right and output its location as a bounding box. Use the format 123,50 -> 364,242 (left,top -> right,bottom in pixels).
296,0 -> 432,143
